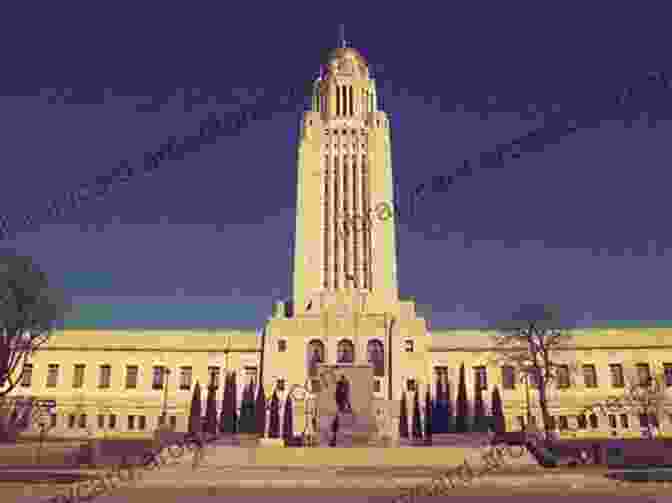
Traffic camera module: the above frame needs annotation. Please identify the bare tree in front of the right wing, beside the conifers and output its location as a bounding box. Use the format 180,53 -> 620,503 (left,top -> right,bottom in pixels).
491,304 -> 571,439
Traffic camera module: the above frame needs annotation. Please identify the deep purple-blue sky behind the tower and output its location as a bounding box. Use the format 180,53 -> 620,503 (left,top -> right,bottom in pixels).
0,2 -> 672,328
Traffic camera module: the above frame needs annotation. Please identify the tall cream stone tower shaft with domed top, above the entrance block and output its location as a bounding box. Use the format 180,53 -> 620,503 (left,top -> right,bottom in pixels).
293,36 -> 398,315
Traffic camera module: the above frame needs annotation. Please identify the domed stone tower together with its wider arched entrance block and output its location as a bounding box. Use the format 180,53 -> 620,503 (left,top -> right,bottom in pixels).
263,35 -> 427,438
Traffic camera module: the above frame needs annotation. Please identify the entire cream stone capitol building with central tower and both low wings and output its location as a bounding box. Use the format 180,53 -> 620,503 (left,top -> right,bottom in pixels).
7,39 -> 672,438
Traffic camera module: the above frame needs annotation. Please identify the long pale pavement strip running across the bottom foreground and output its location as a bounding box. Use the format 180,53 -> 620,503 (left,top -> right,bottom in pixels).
0,466 -> 672,489
